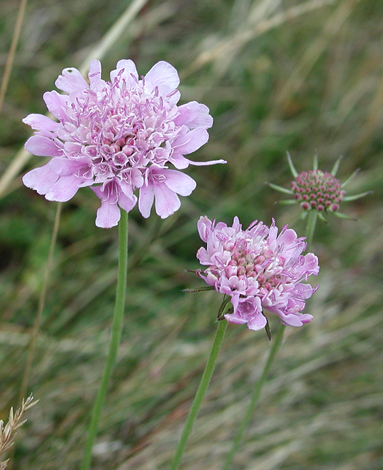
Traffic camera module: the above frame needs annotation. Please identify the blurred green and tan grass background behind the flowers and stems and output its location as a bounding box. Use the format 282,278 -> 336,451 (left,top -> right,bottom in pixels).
0,0 -> 383,470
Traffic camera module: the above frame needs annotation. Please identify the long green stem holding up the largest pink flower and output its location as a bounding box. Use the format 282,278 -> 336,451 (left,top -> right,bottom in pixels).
81,210 -> 128,470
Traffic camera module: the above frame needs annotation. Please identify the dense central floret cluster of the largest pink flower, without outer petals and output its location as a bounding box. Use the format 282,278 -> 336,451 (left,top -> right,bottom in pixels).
58,77 -> 178,183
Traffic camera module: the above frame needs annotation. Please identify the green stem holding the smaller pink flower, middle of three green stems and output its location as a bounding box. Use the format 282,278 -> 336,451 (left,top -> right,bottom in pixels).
170,320 -> 227,470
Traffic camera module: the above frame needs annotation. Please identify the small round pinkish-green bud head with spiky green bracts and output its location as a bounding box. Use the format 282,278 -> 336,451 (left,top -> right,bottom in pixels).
269,154 -> 371,220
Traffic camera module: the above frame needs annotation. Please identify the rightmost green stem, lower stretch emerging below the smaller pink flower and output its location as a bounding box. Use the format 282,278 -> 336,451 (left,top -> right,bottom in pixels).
222,325 -> 286,470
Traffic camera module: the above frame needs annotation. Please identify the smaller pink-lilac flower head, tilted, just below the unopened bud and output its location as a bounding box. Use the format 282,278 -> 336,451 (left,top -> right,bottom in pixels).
197,217 -> 319,330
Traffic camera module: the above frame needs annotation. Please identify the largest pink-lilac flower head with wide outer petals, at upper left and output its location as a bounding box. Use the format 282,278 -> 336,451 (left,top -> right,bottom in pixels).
23,60 -> 226,228
